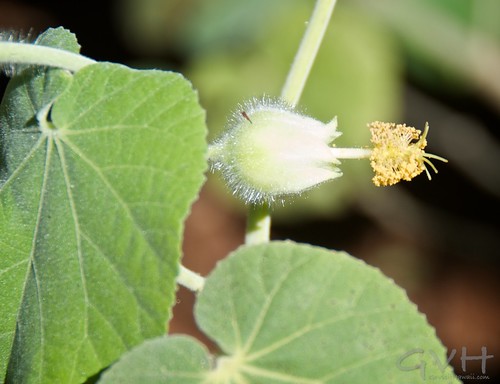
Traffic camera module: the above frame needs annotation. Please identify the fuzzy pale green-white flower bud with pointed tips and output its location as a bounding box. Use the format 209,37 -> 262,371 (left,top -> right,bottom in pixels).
210,99 -> 342,203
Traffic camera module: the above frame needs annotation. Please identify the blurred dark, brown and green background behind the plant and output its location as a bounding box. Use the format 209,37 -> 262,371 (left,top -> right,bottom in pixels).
0,0 -> 500,382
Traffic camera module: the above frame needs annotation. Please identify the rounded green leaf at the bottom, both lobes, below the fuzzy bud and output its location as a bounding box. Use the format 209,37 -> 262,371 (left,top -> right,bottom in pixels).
101,242 -> 458,384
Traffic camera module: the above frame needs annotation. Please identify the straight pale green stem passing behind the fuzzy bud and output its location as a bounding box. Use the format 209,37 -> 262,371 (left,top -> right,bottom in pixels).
245,0 -> 336,244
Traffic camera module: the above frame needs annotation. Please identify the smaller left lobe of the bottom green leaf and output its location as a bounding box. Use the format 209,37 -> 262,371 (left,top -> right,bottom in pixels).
99,336 -> 212,384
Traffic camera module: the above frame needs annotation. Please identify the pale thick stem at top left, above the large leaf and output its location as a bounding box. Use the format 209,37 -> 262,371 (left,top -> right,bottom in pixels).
0,42 -> 95,72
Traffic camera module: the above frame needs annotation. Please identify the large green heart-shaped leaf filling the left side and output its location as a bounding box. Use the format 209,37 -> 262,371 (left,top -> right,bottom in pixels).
0,55 -> 206,383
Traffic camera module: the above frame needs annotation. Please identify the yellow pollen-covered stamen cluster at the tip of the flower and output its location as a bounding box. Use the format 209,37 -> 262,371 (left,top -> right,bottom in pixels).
368,121 -> 448,186
